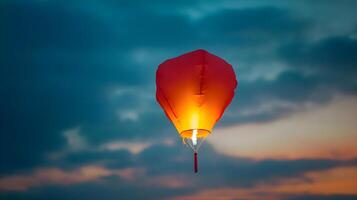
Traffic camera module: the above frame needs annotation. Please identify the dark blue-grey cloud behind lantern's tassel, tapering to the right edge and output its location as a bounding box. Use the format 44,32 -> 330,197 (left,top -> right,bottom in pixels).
138,144 -> 357,188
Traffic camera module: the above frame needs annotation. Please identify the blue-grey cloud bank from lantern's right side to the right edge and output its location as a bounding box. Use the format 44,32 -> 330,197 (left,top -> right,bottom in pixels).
224,36 -> 357,124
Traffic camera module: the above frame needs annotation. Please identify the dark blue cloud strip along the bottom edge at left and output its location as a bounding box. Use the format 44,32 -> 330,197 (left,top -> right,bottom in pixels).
0,181 -> 192,200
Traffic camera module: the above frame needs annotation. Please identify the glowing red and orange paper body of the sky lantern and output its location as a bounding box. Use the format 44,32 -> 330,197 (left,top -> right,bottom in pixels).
156,49 -> 237,138
